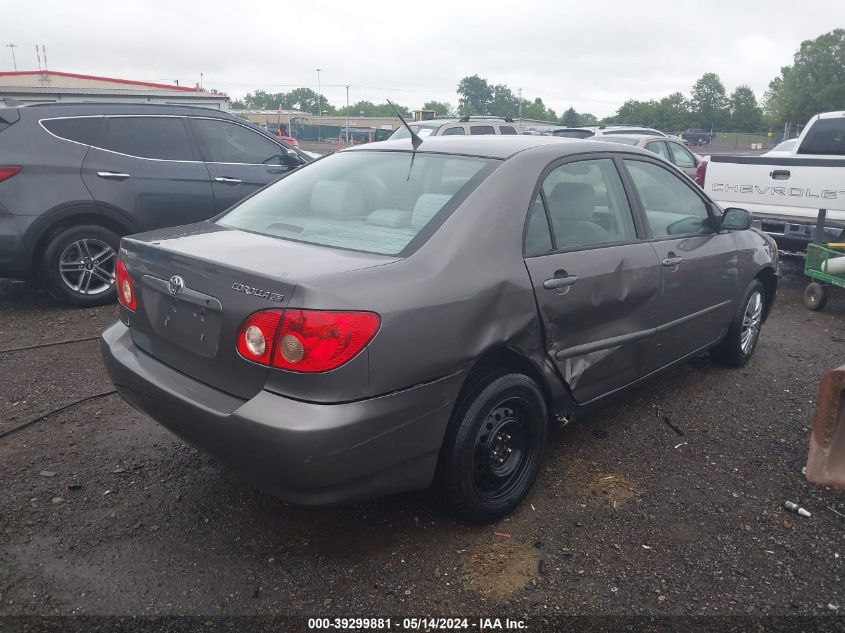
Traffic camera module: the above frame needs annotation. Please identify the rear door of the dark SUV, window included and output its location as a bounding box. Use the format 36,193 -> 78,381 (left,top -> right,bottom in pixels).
82,116 -> 214,230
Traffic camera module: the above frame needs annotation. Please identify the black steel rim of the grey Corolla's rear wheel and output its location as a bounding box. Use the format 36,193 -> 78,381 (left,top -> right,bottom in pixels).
472,398 -> 532,501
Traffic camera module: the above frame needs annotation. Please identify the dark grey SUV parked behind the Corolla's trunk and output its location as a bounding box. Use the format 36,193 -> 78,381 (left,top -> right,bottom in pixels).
0,103 -> 311,306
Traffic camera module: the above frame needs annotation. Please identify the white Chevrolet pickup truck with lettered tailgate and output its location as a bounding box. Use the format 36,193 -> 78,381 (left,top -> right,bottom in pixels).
697,111 -> 845,250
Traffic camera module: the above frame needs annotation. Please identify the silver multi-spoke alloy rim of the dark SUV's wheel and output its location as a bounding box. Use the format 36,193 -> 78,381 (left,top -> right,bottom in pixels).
58,238 -> 117,296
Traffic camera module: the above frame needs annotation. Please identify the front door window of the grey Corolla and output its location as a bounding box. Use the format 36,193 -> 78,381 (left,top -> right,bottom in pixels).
625,159 -> 713,239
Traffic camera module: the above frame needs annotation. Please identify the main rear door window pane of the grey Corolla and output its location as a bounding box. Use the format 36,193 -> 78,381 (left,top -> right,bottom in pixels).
542,158 -> 636,249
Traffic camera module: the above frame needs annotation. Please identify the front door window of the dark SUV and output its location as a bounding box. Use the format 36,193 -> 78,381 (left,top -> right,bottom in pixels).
194,119 -> 286,165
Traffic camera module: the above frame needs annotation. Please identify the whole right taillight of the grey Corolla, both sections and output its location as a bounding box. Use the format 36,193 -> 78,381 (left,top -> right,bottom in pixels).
237,309 -> 381,373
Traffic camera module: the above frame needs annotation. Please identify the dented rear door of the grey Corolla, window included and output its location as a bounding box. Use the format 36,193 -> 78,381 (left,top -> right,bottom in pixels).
525,155 -> 660,403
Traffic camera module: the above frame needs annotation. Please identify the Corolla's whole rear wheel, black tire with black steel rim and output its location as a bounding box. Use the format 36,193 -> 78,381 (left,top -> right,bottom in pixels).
438,372 -> 549,523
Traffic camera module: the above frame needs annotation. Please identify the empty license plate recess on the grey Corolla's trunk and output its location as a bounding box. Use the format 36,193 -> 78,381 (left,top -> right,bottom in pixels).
142,276 -> 221,358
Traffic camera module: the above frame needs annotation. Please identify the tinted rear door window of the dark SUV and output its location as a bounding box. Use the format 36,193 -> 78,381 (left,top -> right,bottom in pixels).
94,116 -> 193,160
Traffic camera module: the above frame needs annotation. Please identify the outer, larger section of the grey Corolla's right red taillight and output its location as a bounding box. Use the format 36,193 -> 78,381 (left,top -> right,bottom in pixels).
273,310 -> 381,373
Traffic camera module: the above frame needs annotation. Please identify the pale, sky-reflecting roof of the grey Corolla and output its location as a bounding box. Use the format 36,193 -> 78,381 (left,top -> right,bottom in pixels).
341,134 -> 650,159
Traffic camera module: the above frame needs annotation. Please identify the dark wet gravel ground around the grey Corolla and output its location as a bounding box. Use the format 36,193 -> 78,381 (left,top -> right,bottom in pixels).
0,262 -> 845,616
